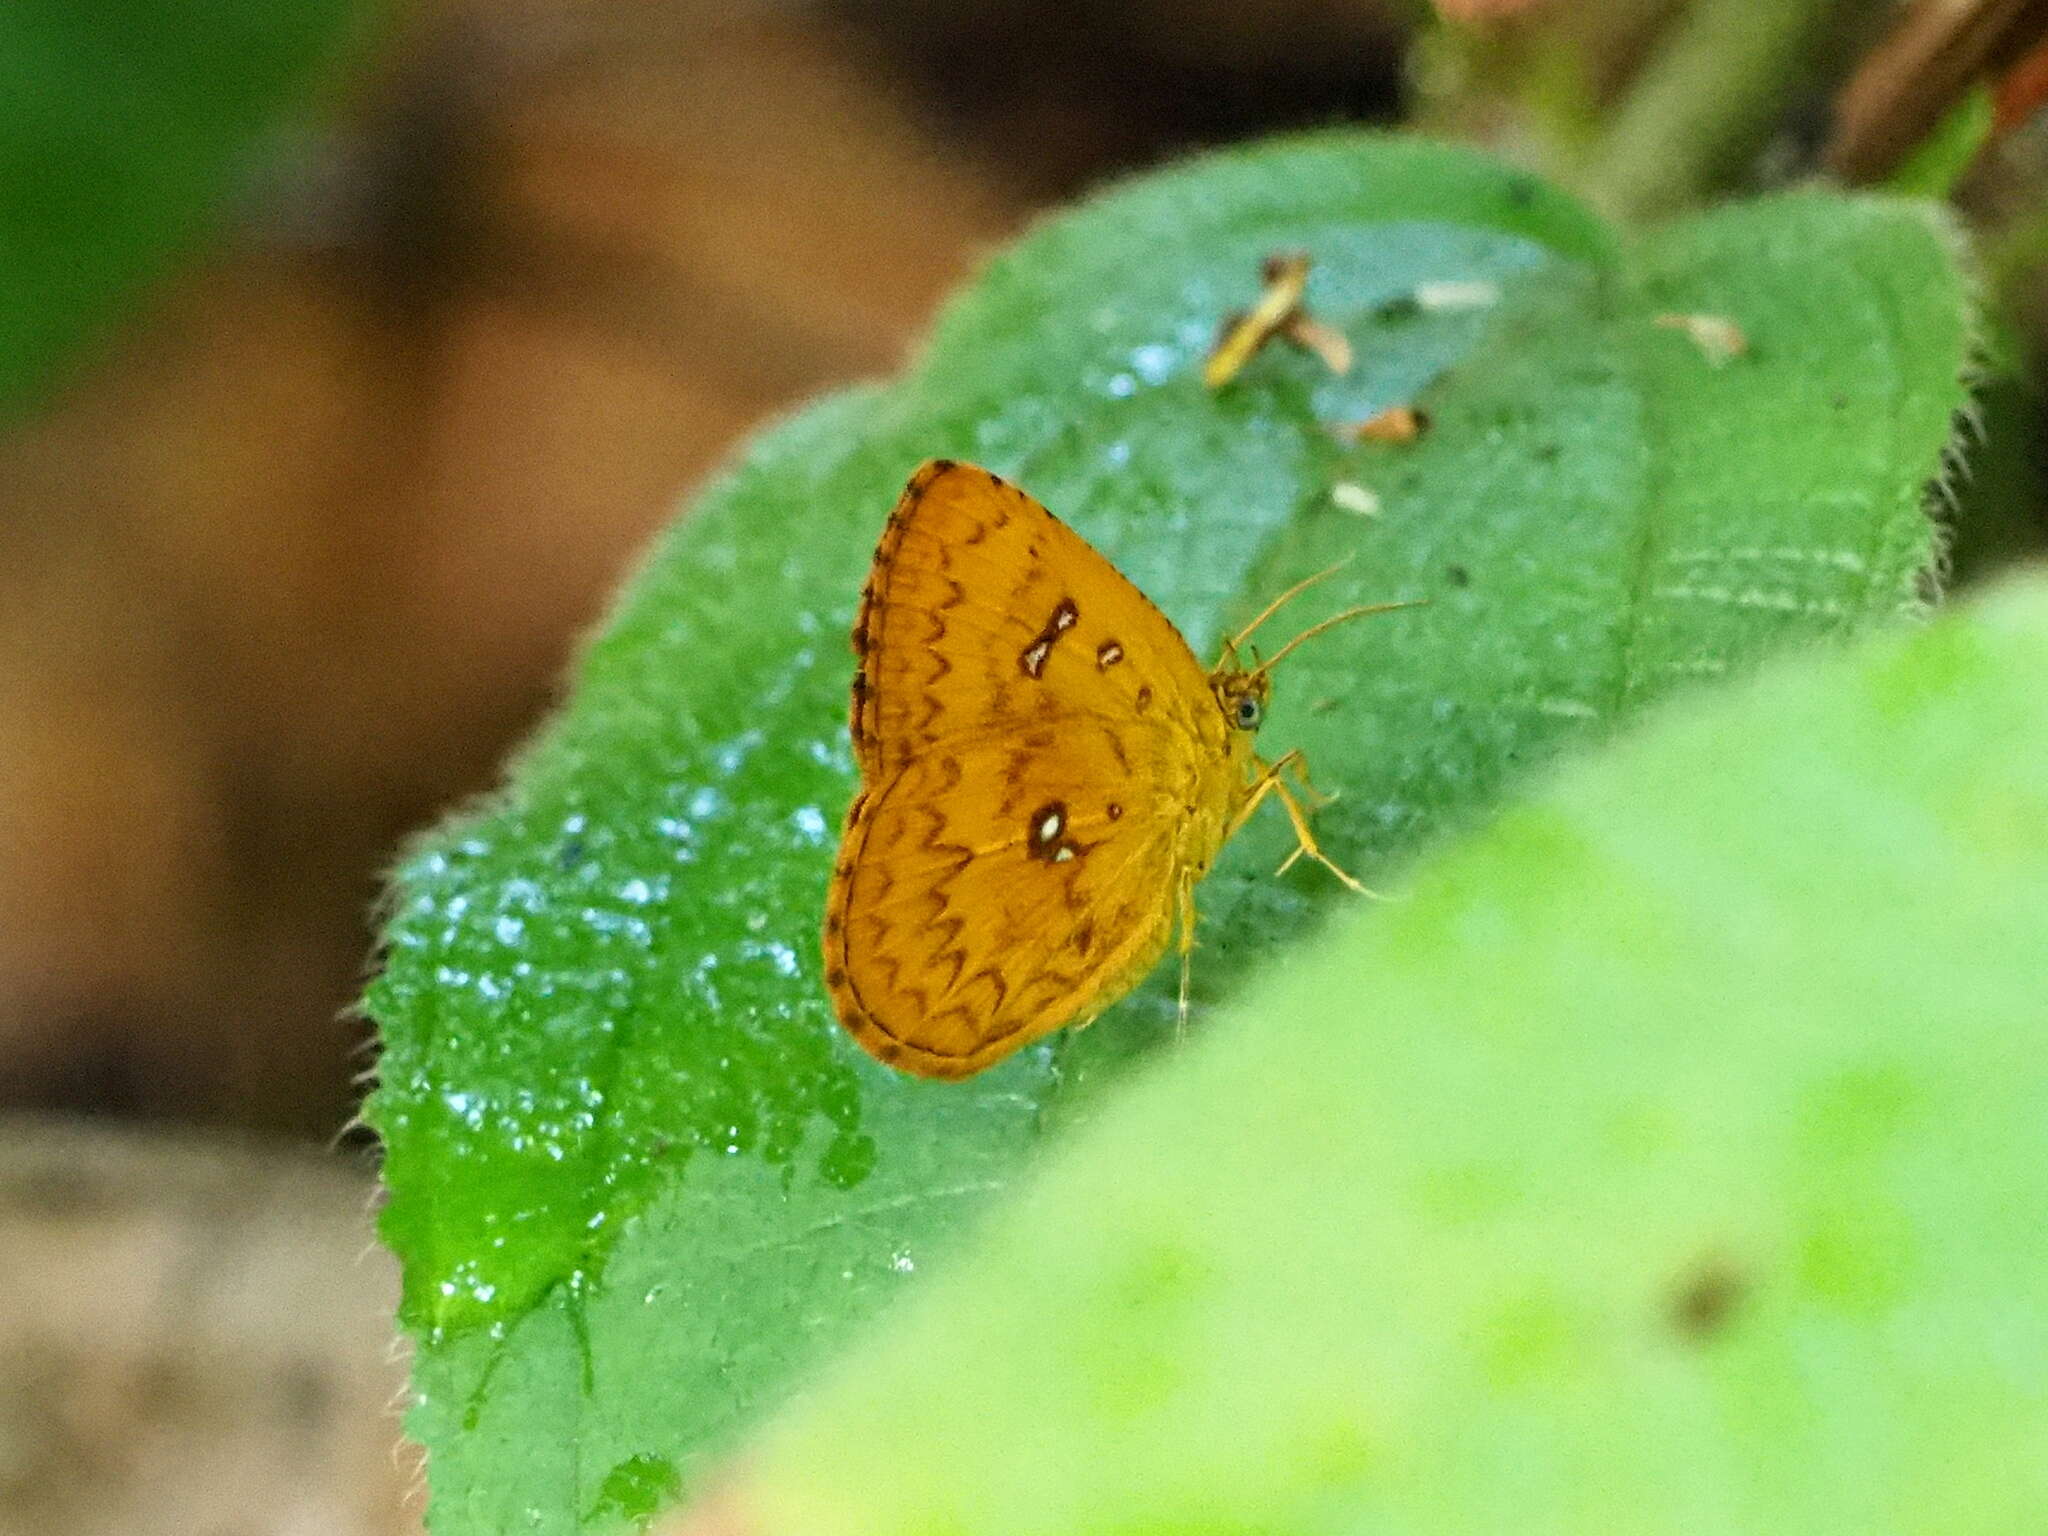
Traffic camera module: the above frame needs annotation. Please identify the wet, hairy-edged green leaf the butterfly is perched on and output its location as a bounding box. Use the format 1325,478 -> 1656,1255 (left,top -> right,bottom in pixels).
369,135 -> 1968,1532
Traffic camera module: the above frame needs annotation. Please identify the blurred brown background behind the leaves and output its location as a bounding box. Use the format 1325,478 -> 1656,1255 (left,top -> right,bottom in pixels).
0,0 -> 2048,1536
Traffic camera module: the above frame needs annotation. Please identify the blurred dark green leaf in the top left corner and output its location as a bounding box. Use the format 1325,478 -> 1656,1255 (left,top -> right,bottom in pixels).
0,0 -> 369,420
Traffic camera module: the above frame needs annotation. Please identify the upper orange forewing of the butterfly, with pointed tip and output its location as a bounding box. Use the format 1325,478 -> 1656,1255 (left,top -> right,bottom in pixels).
852,459 -> 1221,784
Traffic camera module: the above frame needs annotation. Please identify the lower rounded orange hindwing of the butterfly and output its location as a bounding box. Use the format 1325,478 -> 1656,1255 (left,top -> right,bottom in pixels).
825,713 -> 1174,1077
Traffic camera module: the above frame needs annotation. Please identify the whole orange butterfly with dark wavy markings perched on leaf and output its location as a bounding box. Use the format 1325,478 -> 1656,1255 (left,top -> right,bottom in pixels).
825,459 -> 1411,1077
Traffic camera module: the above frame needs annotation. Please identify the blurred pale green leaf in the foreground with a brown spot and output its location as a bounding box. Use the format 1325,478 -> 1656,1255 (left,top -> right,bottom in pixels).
741,578 -> 2048,1536
